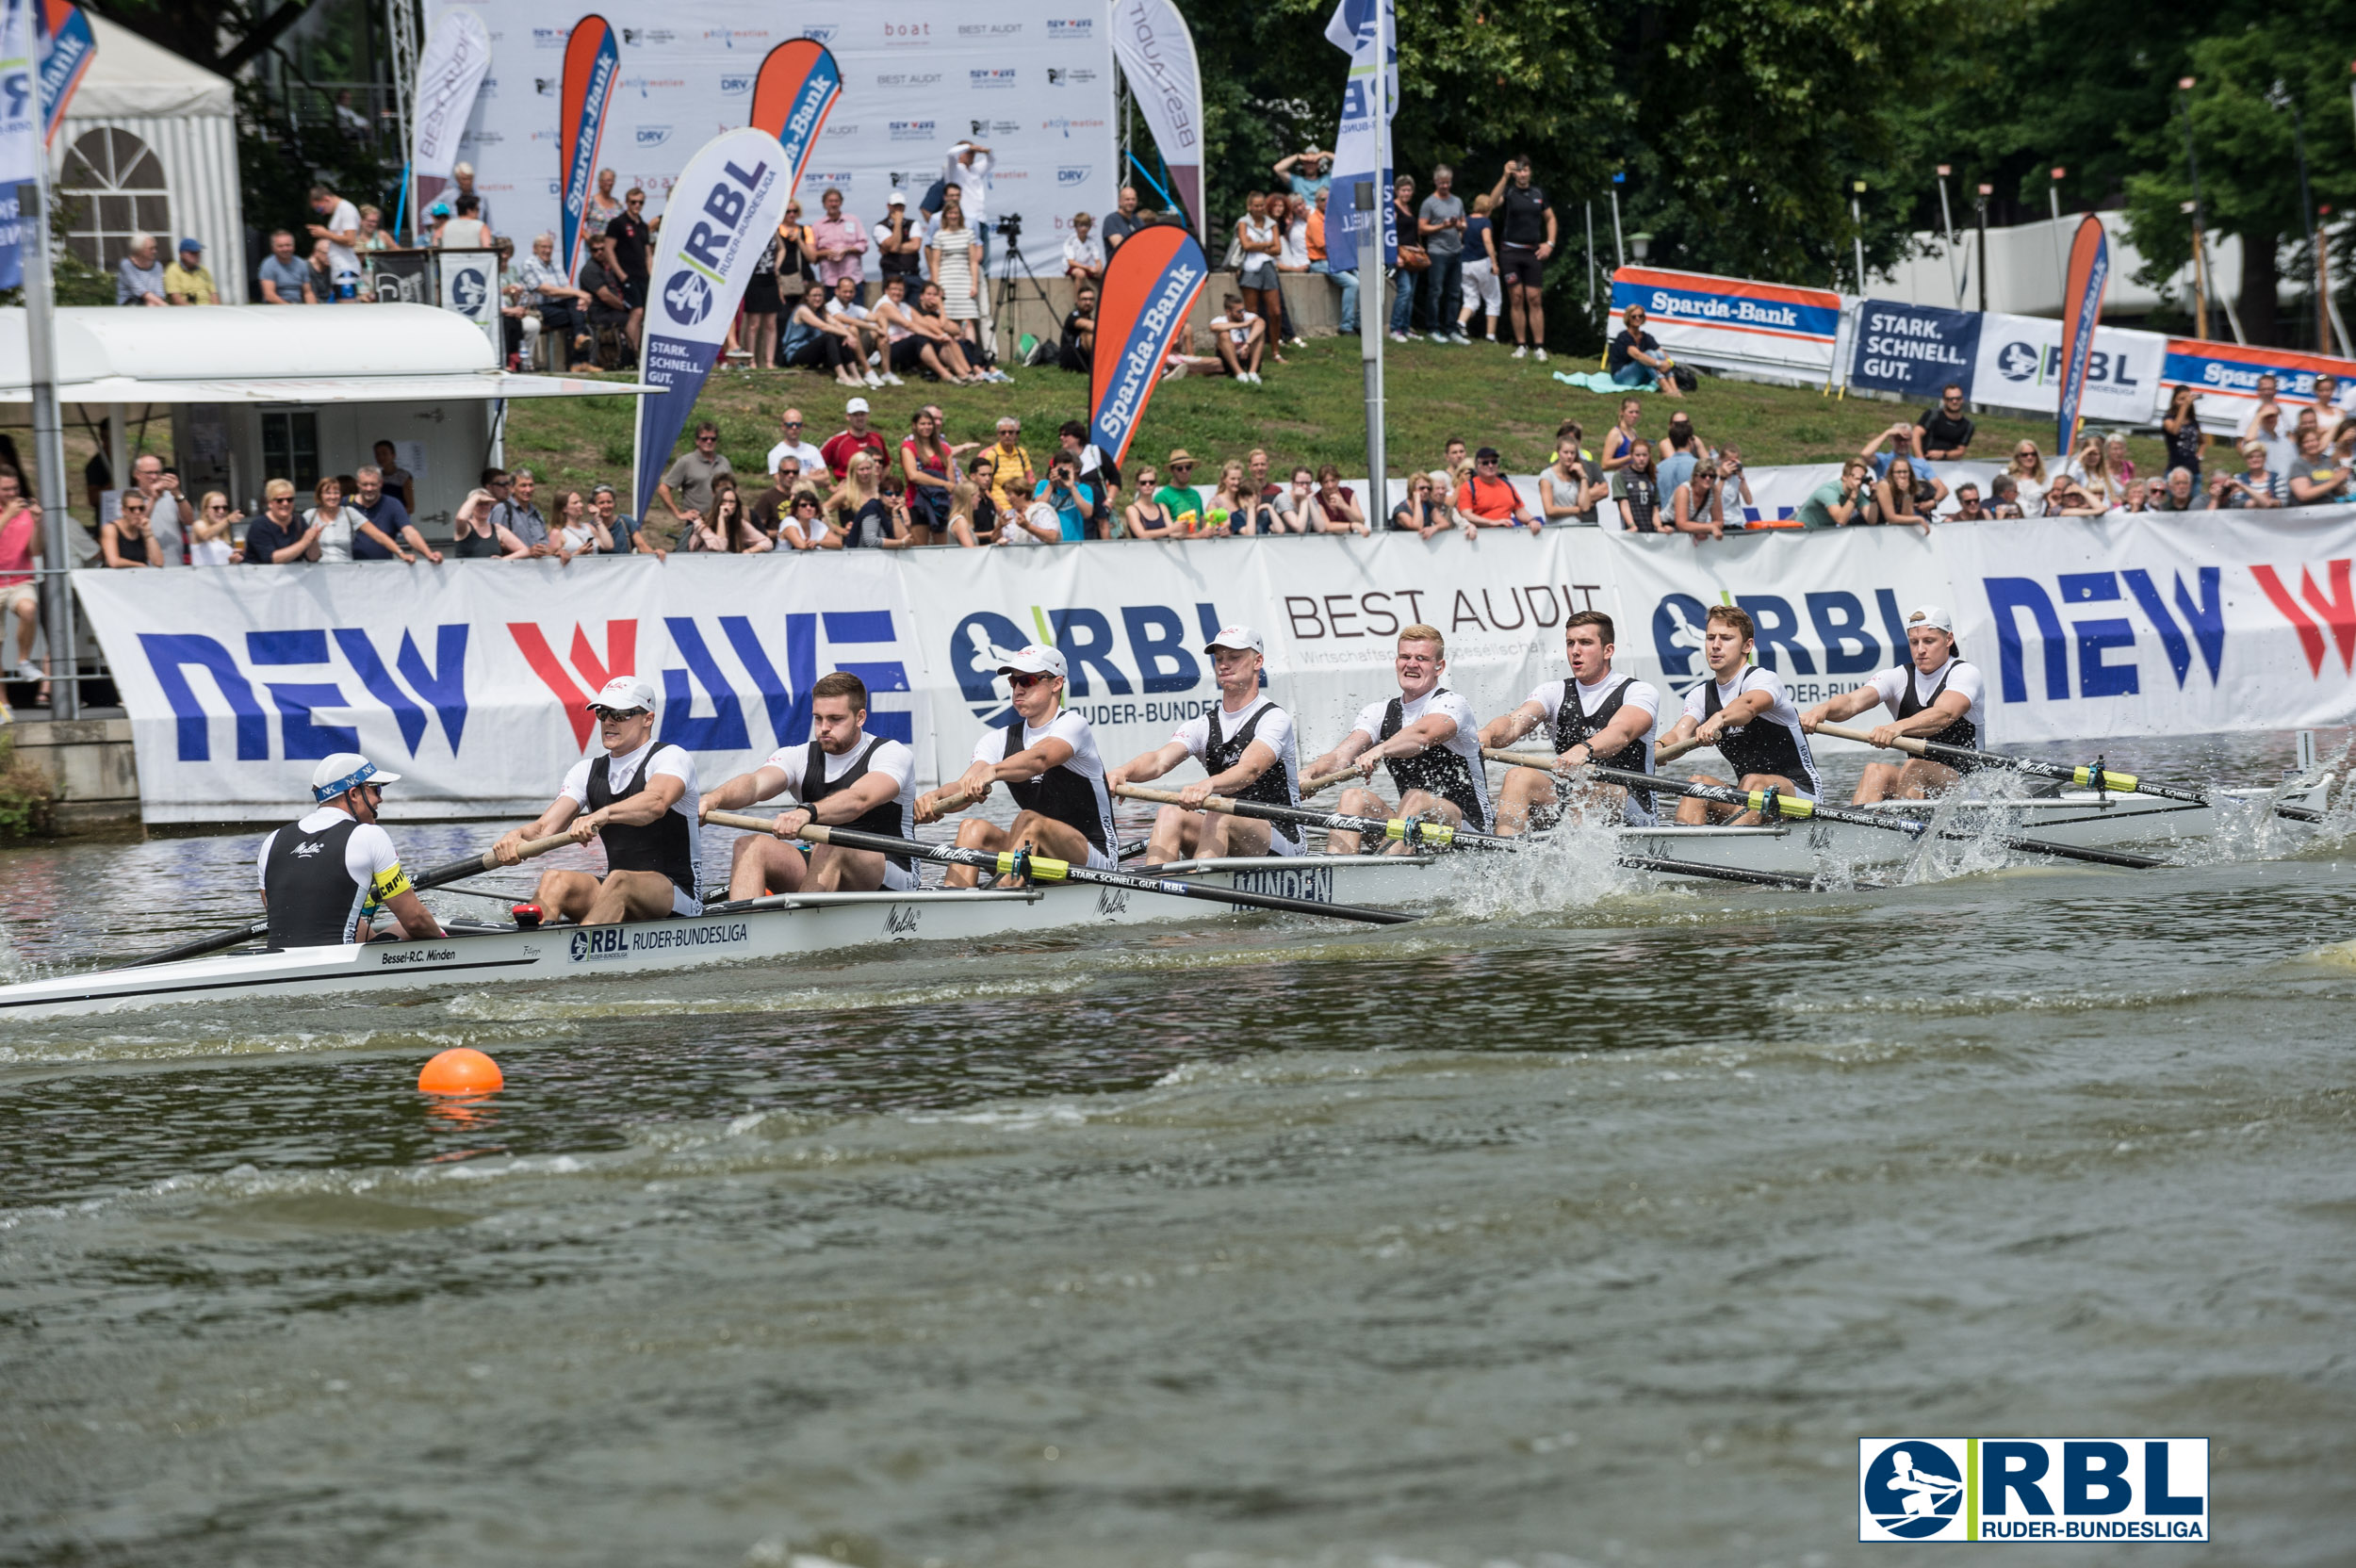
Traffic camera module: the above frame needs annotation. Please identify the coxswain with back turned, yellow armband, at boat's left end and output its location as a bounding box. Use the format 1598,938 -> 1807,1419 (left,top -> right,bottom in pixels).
254,751 -> 443,949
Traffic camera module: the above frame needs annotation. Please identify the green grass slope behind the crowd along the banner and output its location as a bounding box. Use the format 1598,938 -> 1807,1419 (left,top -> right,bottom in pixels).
507,336 -> 2161,485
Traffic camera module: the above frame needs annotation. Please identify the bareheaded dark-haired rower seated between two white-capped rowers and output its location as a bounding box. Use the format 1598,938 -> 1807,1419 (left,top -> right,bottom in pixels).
702,669 -> 917,899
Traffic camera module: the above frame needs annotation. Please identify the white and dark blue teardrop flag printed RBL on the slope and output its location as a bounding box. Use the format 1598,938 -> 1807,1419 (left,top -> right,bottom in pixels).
631,124 -> 787,518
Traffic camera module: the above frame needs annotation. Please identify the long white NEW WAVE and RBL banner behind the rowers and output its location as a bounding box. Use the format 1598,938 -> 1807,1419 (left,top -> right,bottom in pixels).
75,509 -> 2356,822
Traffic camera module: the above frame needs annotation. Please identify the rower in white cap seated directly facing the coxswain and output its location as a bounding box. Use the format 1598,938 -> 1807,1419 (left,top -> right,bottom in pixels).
490,676 -> 705,925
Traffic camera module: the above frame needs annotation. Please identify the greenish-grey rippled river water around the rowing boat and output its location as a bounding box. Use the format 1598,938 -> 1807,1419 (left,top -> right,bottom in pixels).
0,737 -> 2356,1568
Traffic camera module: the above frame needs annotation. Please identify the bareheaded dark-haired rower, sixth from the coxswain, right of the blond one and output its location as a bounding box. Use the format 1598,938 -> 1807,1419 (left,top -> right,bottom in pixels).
1480,610 -> 1661,838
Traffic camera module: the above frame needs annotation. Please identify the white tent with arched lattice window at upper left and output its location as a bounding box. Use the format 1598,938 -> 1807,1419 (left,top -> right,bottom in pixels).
50,11 -> 245,303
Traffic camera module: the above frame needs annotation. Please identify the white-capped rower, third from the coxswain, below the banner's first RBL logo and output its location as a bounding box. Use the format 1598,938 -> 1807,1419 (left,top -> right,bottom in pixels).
917,643 -> 1120,888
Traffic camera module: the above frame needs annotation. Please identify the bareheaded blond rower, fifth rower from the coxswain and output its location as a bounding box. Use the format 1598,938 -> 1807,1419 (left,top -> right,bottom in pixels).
1310,627 -> 1489,855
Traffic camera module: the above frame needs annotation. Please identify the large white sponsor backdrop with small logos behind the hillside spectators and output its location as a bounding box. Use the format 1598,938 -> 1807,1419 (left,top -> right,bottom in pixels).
427,0 -> 1120,273
